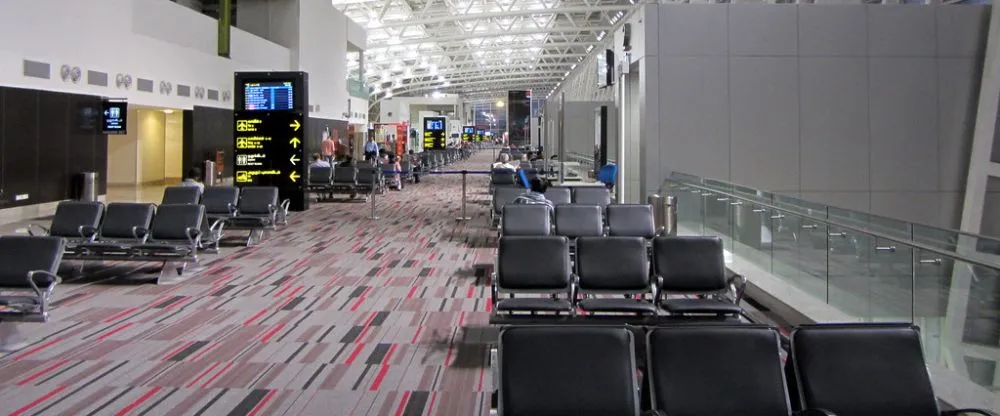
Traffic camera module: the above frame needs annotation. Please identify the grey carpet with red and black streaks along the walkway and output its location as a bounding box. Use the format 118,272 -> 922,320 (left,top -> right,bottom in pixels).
0,151 -> 496,416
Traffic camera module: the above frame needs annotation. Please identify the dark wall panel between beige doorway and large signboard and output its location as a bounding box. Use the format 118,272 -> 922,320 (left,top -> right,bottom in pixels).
183,107 -> 233,177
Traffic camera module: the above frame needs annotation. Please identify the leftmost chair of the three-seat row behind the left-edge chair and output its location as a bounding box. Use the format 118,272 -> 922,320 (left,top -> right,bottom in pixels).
28,201 -> 104,245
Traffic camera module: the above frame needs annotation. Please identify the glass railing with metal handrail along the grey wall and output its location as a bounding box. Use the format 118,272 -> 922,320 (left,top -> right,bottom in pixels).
661,175 -> 1000,394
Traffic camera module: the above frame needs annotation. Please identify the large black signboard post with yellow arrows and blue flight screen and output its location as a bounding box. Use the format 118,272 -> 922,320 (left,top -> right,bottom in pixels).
233,72 -> 309,211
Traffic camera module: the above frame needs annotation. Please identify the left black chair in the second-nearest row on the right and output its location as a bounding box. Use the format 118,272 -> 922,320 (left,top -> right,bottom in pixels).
491,236 -> 575,313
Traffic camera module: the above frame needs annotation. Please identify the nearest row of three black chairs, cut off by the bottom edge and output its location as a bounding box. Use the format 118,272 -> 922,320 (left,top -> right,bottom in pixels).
497,324 -> 994,416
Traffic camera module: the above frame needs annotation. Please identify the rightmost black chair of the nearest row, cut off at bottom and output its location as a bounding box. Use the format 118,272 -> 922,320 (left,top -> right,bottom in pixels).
785,324 -> 995,416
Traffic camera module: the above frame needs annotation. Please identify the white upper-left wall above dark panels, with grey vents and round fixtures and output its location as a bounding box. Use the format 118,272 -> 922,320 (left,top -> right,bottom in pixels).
0,0 -> 290,108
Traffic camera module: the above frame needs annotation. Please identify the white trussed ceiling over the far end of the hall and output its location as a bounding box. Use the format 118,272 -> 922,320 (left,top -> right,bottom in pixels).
332,0 -> 636,100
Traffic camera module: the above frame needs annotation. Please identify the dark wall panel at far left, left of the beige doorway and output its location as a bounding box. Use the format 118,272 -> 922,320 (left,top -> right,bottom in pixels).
0,87 -> 107,208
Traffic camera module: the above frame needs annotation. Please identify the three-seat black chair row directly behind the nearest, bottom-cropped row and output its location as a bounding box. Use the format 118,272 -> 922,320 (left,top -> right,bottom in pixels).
491,236 -> 747,318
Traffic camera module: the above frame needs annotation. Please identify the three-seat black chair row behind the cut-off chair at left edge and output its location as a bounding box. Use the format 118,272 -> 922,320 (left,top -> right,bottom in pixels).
28,201 -> 205,282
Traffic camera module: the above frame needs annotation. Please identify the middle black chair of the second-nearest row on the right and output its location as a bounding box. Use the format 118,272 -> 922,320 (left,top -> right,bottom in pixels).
575,237 -> 657,315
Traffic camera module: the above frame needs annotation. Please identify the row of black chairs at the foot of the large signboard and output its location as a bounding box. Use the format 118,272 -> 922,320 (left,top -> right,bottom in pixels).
160,186 -> 291,250
